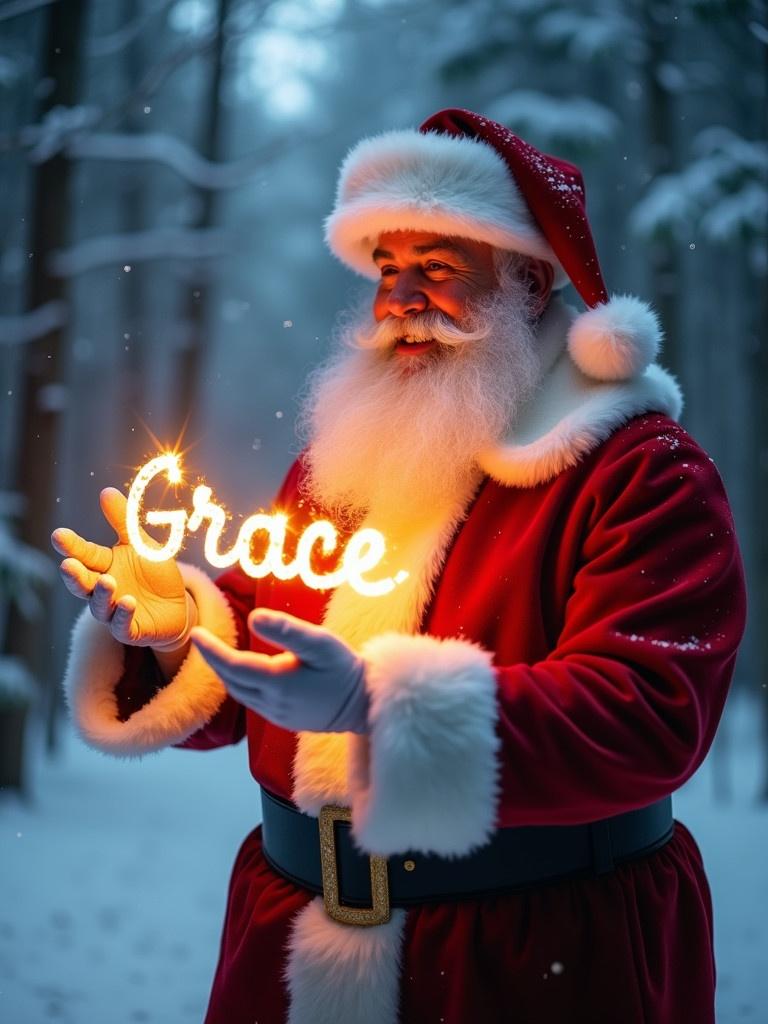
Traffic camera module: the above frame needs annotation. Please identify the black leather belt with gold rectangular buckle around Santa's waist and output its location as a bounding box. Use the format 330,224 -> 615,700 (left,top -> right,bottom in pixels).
261,787 -> 674,925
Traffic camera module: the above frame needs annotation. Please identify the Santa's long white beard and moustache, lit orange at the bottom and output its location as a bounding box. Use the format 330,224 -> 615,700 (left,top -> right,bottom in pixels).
301,274 -> 541,523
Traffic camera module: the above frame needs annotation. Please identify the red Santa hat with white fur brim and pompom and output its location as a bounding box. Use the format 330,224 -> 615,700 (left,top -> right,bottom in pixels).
326,109 -> 662,380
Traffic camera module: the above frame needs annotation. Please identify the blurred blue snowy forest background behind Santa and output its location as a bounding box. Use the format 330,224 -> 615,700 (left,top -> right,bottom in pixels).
0,0 -> 768,1024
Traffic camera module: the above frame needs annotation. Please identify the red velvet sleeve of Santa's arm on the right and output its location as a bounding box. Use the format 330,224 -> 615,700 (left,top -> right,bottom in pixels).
496,423 -> 745,825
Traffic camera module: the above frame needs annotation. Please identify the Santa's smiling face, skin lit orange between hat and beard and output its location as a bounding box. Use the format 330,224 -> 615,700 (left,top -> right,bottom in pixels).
373,231 -> 498,358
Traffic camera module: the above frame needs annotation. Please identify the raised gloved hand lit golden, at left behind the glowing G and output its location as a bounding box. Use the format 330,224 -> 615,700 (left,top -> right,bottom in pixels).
51,487 -> 198,652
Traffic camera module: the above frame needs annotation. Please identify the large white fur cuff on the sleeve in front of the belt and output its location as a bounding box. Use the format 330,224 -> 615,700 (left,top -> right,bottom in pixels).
349,633 -> 500,856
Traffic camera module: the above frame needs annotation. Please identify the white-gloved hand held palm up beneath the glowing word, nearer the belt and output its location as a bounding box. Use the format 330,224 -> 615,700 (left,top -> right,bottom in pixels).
191,608 -> 368,732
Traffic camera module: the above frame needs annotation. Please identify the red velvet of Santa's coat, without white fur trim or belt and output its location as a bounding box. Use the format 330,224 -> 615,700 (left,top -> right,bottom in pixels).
180,415 -> 744,1024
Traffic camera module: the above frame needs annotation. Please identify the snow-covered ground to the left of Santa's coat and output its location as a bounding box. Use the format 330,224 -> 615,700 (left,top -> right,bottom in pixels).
0,730 -> 260,1024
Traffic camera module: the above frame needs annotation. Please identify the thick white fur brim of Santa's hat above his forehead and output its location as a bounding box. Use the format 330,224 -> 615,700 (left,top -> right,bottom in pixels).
326,130 -> 567,287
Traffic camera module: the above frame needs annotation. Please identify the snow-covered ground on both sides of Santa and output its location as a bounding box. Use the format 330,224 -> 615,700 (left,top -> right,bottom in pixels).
0,703 -> 768,1024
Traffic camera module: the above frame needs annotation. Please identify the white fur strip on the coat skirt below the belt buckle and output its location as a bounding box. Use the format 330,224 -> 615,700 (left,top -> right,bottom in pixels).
286,897 -> 406,1024
